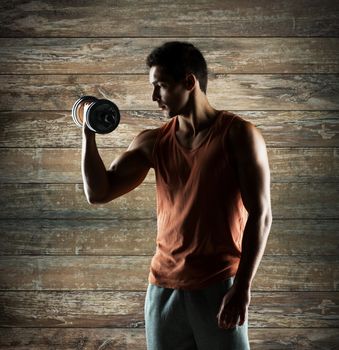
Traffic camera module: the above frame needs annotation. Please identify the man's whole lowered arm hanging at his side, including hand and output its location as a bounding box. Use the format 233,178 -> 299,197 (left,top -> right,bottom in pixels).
217,120 -> 272,328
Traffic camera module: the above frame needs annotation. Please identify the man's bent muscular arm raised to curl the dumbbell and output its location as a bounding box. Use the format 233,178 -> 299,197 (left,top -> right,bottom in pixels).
81,121 -> 156,204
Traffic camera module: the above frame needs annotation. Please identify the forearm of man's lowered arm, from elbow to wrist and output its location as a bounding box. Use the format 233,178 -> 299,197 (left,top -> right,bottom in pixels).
234,211 -> 272,288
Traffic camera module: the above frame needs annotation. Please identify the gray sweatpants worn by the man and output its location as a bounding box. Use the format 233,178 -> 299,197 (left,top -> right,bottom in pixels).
144,277 -> 250,350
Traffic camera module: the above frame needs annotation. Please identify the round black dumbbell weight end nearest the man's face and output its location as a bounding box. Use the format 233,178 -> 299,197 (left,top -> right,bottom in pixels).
86,99 -> 120,134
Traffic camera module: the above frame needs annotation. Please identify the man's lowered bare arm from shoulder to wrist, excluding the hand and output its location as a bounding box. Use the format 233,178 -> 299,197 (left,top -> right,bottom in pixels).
230,122 -> 272,288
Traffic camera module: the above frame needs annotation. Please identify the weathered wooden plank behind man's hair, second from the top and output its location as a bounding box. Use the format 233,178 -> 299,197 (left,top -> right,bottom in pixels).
0,37 -> 339,74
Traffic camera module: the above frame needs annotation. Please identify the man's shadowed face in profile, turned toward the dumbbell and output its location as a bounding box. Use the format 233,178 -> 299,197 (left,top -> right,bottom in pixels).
149,66 -> 189,118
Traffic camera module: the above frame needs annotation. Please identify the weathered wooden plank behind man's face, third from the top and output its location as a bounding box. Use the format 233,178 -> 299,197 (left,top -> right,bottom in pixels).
0,74 -> 339,111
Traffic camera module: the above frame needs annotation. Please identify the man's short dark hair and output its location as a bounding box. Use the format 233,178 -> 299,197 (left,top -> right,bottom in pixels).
146,41 -> 208,94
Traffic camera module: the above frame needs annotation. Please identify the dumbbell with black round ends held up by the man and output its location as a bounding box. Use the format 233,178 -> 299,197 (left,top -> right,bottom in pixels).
72,96 -> 120,134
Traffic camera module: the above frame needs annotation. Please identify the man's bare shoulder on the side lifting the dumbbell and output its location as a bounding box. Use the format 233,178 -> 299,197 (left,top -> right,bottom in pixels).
127,128 -> 160,167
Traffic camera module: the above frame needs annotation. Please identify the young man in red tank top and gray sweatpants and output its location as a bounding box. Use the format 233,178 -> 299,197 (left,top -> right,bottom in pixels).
82,42 -> 272,350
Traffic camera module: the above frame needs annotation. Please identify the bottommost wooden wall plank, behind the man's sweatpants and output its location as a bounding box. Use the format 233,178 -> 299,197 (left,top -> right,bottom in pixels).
0,326 -> 338,350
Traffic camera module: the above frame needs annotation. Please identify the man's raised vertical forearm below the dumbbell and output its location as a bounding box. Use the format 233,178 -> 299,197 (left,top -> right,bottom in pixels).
81,134 -> 108,203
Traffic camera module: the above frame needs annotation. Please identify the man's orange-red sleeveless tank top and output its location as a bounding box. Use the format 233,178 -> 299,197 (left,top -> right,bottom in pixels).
148,111 -> 247,290
